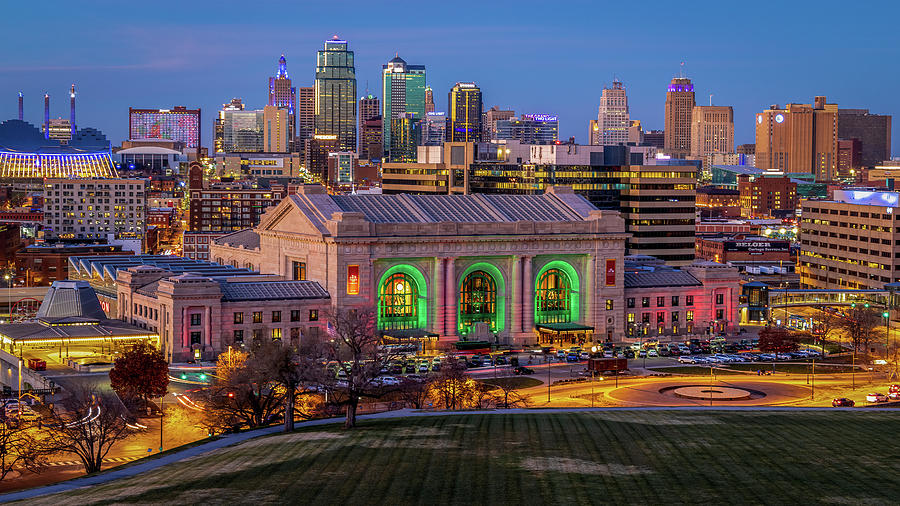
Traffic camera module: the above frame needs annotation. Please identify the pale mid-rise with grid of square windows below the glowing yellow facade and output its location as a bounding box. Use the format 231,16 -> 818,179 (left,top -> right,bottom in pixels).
43,178 -> 148,241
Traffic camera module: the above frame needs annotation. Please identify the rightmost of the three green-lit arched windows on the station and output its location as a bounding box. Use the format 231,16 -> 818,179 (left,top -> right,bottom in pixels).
533,260 -> 581,323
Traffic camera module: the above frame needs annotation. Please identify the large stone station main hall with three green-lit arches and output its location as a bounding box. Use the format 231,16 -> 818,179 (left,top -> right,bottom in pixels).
210,185 -> 628,344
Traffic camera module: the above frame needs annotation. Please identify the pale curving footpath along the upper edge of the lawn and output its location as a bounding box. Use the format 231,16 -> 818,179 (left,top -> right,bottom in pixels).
0,406 -> 854,503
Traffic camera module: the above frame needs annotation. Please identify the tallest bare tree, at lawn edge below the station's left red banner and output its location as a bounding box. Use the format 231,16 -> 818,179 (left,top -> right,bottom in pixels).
311,309 -> 392,429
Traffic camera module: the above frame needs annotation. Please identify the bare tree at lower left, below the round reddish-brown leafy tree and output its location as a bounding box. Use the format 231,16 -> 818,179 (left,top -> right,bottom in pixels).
40,390 -> 133,474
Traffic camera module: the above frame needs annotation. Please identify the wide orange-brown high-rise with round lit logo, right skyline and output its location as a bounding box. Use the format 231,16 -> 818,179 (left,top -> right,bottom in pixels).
756,97 -> 838,181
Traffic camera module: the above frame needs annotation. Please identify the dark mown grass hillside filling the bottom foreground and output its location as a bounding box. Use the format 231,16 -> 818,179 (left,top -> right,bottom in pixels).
19,410 -> 900,506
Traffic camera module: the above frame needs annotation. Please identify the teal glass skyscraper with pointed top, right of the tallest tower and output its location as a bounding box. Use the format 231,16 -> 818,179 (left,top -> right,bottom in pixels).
381,55 -> 425,160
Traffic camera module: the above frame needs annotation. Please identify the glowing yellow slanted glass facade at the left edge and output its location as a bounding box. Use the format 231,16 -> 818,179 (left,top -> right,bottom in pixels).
0,151 -> 119,178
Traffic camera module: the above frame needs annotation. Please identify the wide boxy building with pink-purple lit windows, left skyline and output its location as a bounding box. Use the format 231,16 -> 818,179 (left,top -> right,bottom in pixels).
128,106 -> 200,149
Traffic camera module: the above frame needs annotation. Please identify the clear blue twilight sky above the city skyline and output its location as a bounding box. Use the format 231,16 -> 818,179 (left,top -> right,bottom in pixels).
0,0 -> 900,156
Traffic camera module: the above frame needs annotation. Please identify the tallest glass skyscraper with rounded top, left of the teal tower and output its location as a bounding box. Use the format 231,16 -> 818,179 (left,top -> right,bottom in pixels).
315,35 -> 356,151
